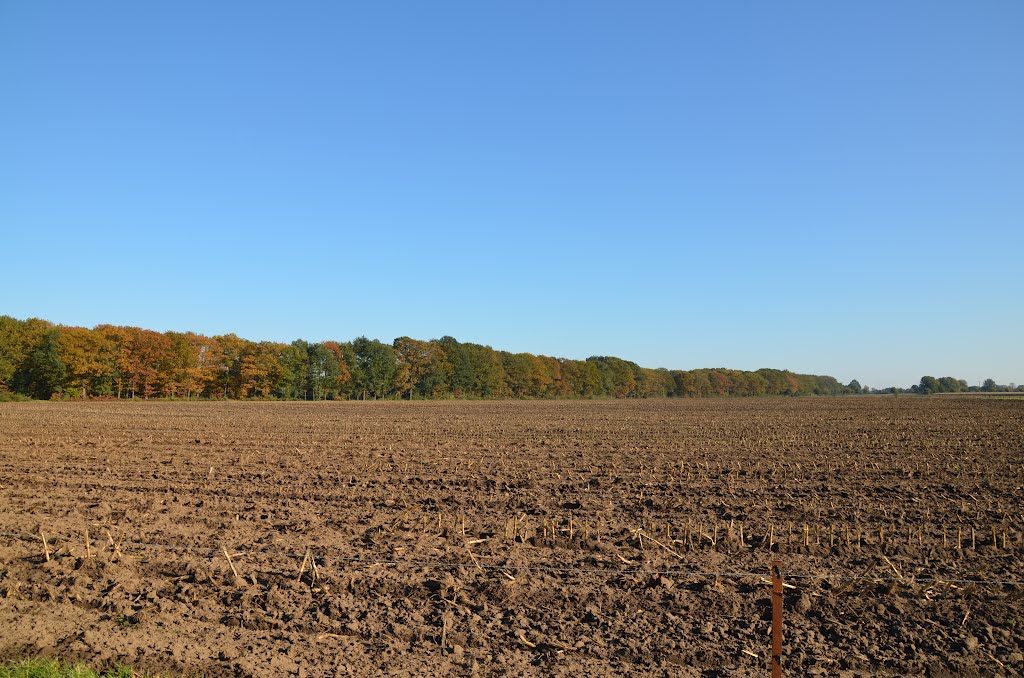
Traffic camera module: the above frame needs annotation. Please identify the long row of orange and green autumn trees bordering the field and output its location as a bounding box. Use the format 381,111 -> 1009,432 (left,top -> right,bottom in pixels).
0,315 -> 860,400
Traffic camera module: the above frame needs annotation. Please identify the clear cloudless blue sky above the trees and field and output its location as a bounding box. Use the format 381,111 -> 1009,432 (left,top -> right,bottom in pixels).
0,0 -> 1024,386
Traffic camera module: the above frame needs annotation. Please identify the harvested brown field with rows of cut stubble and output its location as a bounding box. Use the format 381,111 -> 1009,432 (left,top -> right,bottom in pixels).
0,397 -> 1024,676
